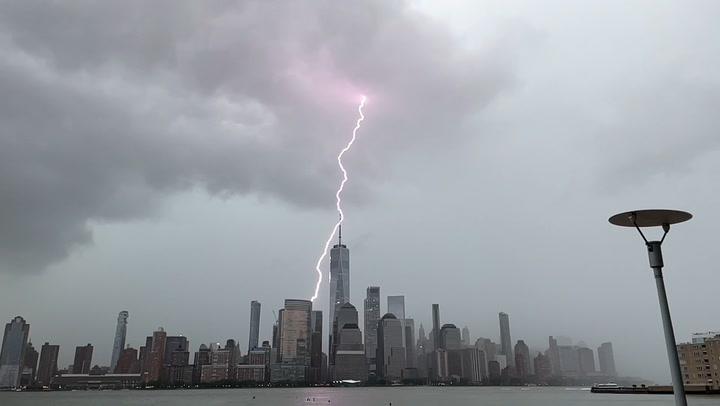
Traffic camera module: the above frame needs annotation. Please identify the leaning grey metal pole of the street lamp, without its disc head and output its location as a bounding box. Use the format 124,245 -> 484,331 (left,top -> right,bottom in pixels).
647,241 -> 687,406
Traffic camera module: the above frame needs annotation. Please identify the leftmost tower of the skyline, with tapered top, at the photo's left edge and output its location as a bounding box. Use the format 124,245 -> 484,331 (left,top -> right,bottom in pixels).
0,316 -> 30,388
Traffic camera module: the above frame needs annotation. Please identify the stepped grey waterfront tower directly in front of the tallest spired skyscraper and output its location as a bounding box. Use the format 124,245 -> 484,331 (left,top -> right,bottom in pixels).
333,322 -> 368,381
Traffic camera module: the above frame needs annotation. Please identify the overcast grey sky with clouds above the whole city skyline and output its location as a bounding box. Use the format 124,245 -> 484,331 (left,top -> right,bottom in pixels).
0,0 -> 720,382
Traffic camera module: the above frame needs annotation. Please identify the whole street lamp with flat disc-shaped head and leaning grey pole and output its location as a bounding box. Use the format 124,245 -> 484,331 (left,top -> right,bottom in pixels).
609,210 -> 692,406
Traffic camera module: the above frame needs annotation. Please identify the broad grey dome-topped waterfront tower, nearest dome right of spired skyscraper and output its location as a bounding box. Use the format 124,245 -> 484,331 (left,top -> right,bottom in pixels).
377,313 -> 405,379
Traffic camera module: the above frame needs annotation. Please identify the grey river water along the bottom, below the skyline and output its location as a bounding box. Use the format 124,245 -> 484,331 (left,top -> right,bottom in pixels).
0,387 -> 720,406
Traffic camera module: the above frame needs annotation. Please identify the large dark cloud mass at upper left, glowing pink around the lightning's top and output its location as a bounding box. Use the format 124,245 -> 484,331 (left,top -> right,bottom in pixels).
0,1 -> 511,271
